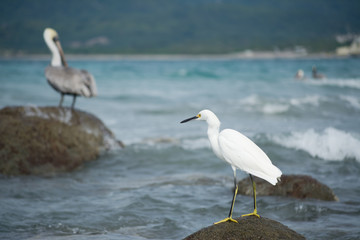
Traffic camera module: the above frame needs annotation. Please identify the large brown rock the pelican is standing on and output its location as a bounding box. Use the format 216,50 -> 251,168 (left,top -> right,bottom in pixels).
0,107 -> 123,175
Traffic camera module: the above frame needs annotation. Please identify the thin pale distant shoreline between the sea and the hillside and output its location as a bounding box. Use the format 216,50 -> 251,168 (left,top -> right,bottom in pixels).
0,51 -> 350,61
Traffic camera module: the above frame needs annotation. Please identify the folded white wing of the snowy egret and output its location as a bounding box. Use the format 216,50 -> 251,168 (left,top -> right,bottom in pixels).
219,129 -> 281,185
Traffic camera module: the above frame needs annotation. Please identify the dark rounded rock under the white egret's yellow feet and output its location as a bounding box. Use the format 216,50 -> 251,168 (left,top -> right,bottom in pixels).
184,216 -> 305,240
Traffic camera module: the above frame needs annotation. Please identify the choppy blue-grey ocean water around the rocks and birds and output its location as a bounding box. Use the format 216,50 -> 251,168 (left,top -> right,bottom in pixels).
0,58 -> 360,240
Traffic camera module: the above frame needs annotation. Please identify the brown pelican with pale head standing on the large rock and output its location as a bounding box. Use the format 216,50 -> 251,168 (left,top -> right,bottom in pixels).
44,28 -> 97,108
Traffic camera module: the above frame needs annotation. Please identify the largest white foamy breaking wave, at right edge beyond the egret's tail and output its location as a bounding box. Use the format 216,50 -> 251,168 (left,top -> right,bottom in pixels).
270,127 -> 360,161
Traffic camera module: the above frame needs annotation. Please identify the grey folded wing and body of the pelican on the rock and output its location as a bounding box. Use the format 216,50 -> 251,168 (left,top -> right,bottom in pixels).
45,66 -> 97,97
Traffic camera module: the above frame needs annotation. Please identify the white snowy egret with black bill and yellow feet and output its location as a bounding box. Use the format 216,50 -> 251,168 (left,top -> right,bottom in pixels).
181,110 -> 282,224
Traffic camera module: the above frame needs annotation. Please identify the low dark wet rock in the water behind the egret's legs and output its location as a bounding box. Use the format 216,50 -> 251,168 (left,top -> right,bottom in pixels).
239,175 -> 338,201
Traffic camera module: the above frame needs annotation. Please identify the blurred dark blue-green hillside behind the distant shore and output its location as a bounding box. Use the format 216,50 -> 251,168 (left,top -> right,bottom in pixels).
0,0 -> 360,54
